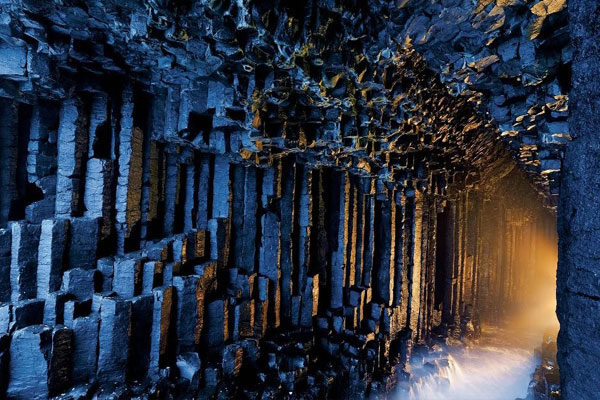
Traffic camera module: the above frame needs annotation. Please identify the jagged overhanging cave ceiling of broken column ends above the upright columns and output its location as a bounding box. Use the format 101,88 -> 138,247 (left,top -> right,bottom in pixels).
0,0 -> 571,205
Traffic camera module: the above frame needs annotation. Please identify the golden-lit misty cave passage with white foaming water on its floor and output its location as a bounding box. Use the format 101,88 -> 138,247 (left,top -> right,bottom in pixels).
397,166 -> 559,400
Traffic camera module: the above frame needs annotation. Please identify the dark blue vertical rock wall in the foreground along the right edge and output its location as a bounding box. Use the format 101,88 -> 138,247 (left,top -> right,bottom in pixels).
557,0 -> 600,399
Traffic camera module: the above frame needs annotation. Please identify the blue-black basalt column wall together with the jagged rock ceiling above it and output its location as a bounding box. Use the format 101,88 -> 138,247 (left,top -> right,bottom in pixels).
0,0 -> 570,398
